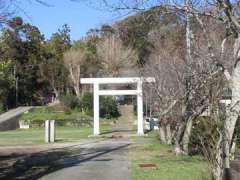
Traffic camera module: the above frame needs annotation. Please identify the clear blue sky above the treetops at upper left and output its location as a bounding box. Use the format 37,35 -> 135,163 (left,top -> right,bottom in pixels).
18,0 -> 119,40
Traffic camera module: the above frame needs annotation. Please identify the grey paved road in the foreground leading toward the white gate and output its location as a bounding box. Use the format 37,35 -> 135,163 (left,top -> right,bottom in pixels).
40,139 -> 130,180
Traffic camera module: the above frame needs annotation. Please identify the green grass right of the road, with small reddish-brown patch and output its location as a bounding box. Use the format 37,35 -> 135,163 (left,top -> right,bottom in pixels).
129,133 -> 211,180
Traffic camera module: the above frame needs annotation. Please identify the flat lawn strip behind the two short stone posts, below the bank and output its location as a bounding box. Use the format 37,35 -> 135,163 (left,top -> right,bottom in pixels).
0,123 -> 112,146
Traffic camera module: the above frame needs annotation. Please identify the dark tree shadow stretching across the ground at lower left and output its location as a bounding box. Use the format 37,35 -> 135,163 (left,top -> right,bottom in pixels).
0,144 -> 130,180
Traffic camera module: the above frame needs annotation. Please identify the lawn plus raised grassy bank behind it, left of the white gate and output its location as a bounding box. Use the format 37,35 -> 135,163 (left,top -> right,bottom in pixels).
0,106 -> 116,146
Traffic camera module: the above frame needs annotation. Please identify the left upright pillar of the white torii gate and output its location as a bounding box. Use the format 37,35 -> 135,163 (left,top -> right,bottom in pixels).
93,83 -> 100,136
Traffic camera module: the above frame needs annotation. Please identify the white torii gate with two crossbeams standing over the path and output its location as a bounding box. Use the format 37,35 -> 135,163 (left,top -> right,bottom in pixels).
80,77 -> 155,136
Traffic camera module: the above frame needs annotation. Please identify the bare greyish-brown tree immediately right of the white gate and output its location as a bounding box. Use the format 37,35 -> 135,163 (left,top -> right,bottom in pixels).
144,27 -> 185,144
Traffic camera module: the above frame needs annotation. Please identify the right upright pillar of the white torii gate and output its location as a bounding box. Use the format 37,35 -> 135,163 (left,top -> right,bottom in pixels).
137,80 -> 144,136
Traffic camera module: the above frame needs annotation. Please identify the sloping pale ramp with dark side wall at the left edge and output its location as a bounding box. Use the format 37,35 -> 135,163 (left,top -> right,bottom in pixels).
0,106 -> 33,130
